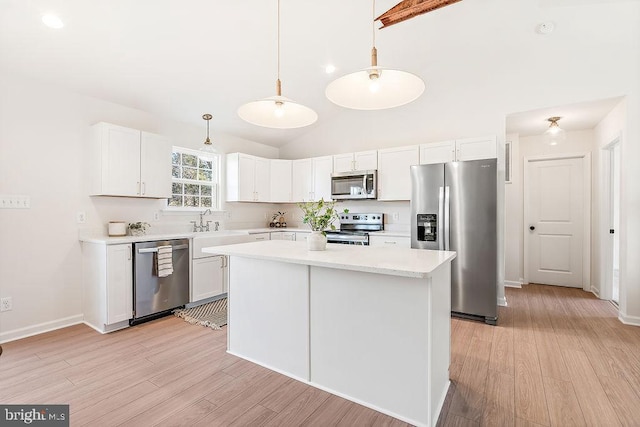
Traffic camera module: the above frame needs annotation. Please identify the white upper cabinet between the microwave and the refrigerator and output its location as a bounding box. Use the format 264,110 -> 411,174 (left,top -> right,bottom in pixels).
378,145 -> 420,200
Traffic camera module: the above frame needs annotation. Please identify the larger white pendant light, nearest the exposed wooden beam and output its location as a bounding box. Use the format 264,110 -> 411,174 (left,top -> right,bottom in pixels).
325,0 -> 425,110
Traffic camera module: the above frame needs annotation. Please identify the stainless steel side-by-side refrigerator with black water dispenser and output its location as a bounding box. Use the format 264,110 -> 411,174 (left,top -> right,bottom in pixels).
411,159 -> 498,325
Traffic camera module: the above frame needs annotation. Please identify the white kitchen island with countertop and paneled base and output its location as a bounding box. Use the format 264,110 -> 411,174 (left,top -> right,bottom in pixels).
203,241 -> 455,426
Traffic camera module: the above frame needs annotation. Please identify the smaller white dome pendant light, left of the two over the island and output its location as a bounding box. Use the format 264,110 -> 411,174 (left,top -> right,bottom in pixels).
238,0 -> 318,129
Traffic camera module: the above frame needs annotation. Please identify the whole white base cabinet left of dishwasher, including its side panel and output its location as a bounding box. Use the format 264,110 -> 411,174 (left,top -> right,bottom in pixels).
82,242 -> 133,333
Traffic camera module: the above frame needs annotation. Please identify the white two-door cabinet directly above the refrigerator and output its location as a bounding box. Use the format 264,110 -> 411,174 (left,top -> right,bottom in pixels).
420,136 -> 498,165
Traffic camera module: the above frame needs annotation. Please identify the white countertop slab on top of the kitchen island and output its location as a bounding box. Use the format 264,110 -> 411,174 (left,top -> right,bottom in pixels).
202,240 -> 456,278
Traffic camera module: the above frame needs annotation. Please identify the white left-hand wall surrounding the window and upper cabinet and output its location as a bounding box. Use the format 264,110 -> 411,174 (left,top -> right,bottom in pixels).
0,72 -> 278,342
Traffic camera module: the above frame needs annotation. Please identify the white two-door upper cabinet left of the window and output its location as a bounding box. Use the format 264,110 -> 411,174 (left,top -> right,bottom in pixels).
88,122 -> 171,199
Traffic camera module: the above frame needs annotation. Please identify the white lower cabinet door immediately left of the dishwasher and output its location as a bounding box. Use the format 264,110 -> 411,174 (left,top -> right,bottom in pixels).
107,245 -> 133,325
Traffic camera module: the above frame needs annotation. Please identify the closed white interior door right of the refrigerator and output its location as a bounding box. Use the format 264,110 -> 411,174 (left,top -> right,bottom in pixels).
524,157 -> 589,288
